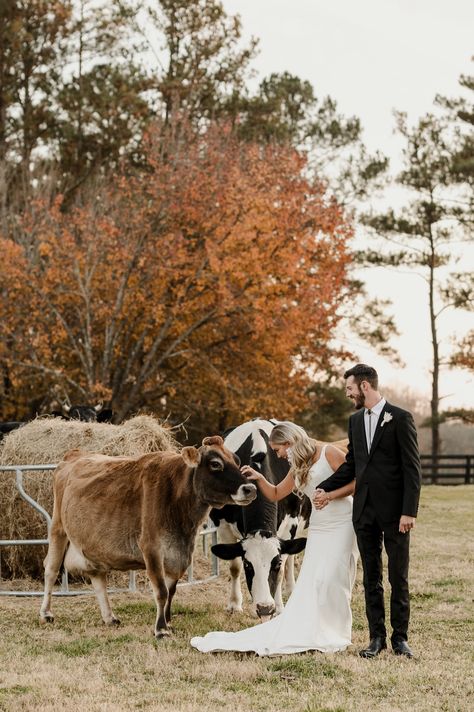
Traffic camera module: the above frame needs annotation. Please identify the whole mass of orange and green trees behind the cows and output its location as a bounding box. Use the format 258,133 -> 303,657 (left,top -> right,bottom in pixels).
0,0 -> 472,438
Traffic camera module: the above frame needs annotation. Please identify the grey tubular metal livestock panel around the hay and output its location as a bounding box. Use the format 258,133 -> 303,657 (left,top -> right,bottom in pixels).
0,464 -> 219,596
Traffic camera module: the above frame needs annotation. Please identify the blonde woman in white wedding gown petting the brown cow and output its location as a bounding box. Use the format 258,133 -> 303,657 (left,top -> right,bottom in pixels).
191,422 -> 357,655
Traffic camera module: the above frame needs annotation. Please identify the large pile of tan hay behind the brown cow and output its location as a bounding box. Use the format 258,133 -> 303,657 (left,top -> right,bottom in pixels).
0,415 -> 179,578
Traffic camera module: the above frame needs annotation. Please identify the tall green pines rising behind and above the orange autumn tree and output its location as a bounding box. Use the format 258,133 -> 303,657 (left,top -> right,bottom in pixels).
0,0 -> 384,206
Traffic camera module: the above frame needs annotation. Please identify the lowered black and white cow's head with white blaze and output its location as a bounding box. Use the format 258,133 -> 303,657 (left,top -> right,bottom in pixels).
211,530 -> 306,619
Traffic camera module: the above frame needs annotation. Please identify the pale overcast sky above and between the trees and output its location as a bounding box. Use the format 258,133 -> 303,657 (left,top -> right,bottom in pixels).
223,0 -> 474,407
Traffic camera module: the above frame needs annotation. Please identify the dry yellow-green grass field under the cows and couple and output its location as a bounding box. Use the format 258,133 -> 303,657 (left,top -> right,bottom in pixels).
0,486 -> 474,712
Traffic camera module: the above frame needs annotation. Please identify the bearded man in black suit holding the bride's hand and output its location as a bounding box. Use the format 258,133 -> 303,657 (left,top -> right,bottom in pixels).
314,363 -> 421,658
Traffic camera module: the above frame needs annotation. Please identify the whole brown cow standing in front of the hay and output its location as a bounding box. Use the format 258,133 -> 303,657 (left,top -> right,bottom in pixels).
40,436 -> 256,638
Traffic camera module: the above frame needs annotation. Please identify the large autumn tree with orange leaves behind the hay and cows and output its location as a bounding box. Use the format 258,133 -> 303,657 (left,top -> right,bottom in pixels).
0,127 -> 351,434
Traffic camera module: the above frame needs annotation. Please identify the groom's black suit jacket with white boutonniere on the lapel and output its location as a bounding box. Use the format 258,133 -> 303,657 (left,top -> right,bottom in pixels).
319,403 -> 421,524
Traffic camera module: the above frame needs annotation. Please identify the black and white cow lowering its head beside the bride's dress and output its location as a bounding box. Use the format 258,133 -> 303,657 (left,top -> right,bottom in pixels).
210,420 -> 311,618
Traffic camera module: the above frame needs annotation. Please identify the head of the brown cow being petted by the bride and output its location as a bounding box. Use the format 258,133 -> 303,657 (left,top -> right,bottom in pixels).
181,435 -> 257,507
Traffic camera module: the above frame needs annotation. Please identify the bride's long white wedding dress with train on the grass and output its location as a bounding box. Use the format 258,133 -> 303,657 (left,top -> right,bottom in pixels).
191,447 -> 357,655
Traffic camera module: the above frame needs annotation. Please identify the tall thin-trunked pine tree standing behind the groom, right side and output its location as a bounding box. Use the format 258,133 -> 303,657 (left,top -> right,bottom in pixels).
359,113 -> 470,455
